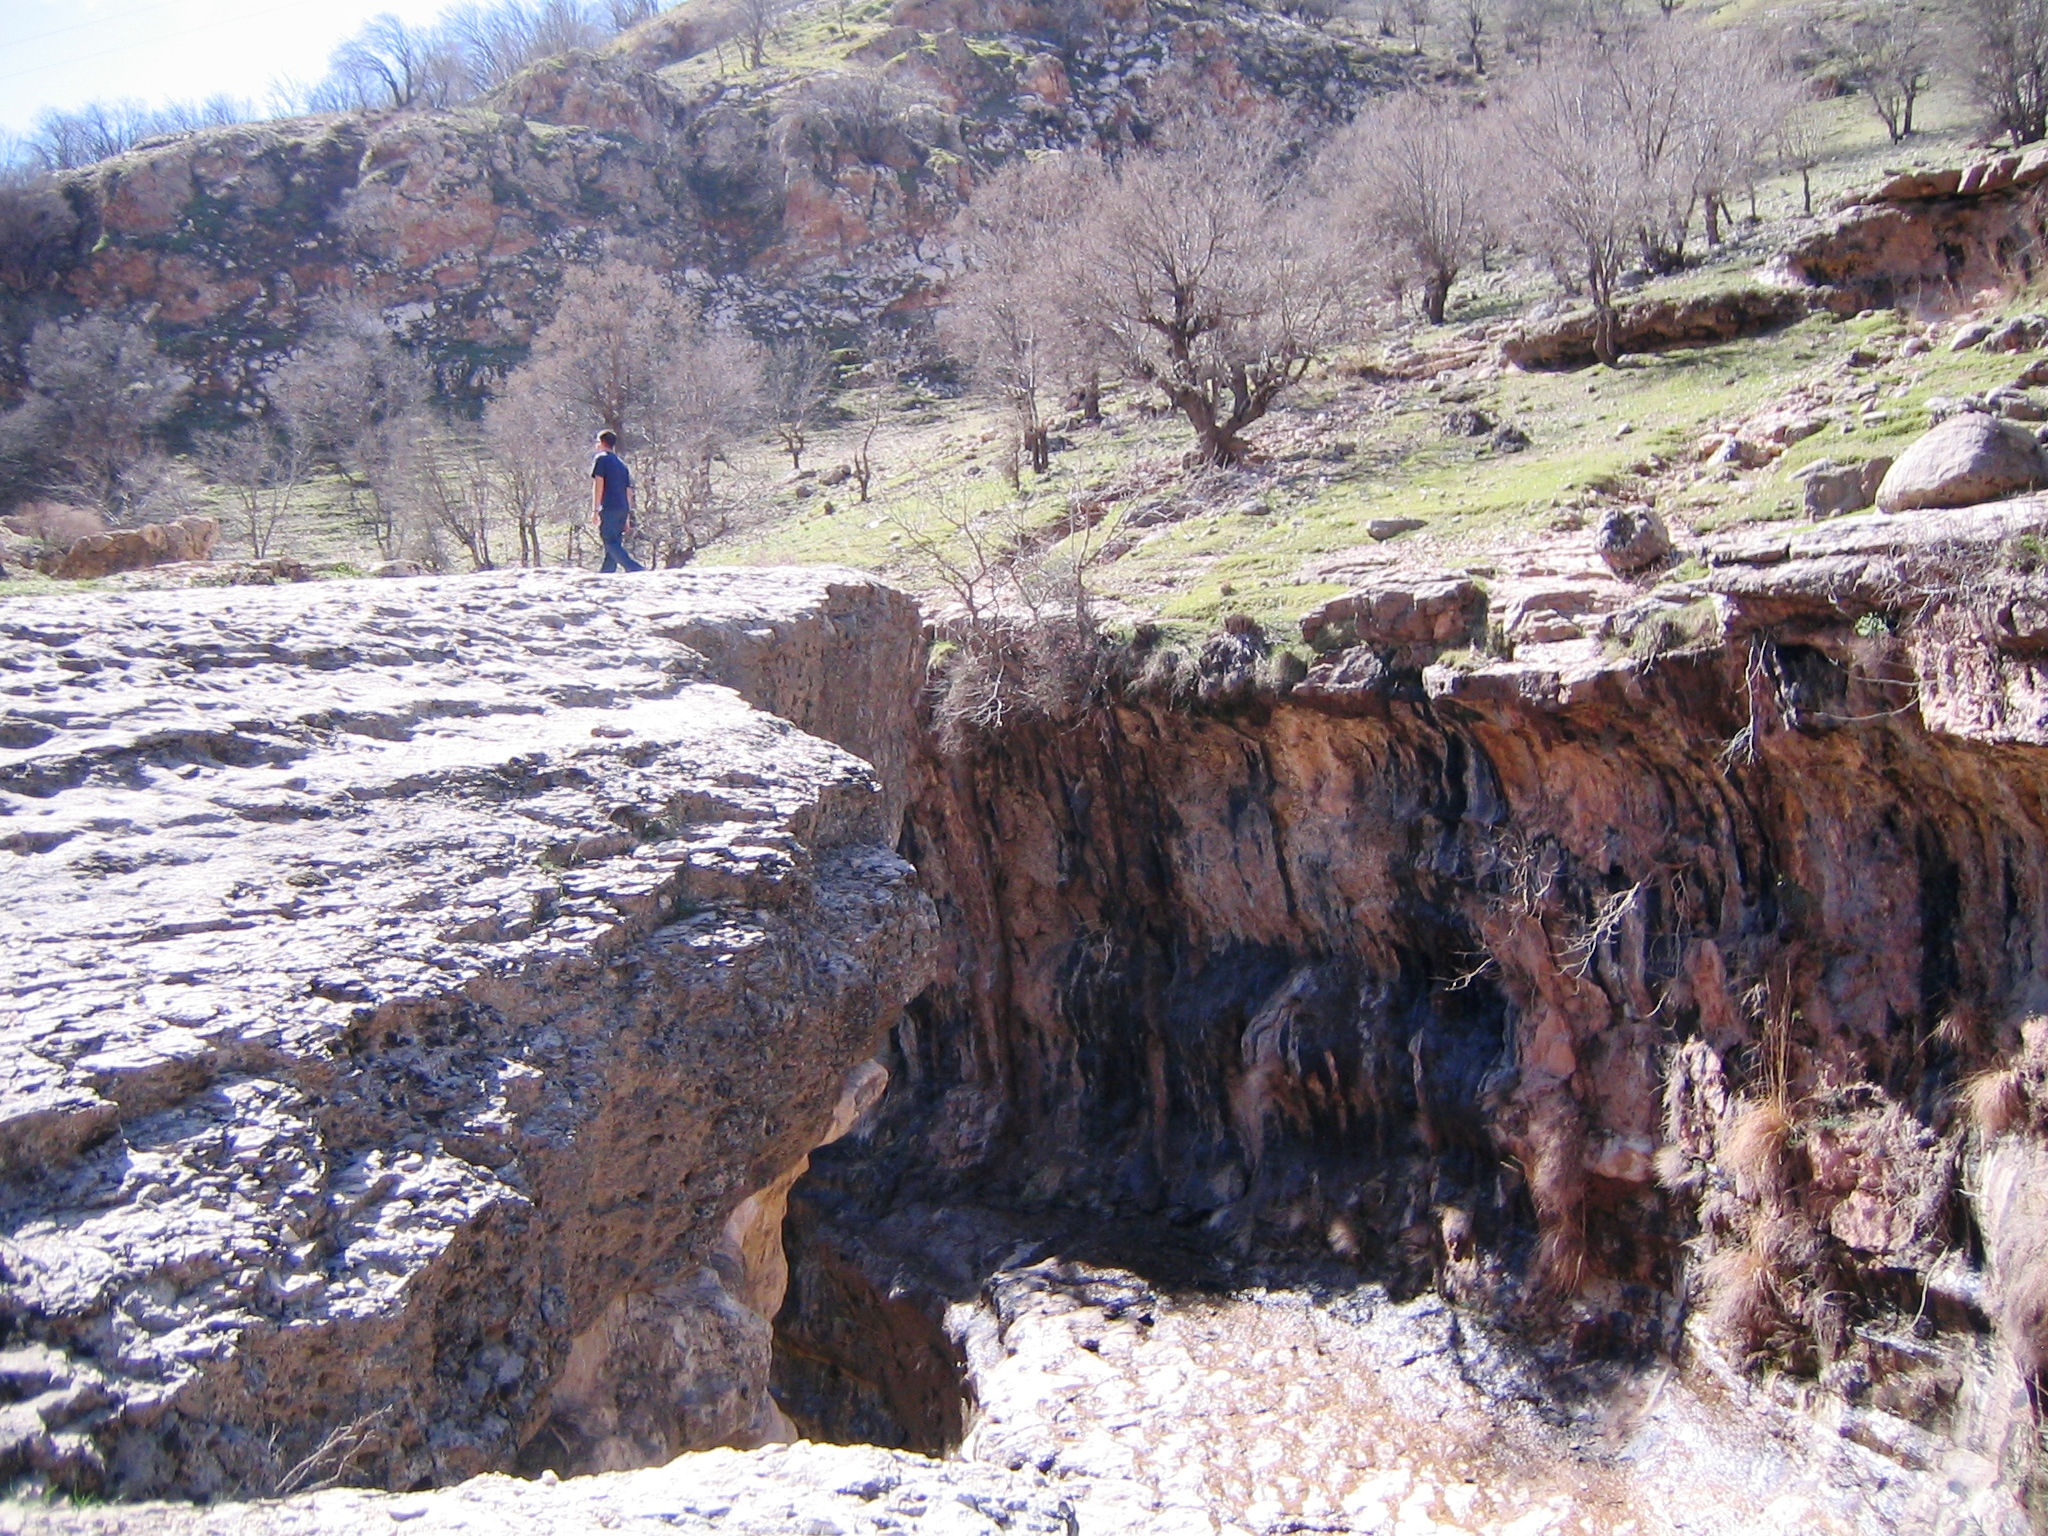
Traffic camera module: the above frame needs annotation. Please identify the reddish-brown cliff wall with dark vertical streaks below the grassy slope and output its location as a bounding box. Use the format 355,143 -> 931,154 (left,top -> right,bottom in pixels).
778,500 -> 2048,1530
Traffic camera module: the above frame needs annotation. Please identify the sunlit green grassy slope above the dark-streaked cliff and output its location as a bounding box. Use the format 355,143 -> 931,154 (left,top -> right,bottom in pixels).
715,70 -> 2025,627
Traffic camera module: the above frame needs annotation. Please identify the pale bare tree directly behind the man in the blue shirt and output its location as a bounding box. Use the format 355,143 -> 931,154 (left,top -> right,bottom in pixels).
504,260 -> 760,565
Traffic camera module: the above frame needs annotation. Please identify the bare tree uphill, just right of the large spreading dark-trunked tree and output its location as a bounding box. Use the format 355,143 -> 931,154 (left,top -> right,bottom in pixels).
1323,90 -> 1497,326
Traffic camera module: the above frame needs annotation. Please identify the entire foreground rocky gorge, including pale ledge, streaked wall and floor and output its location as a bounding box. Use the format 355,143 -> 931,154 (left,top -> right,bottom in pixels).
0,520 -> 2048,1536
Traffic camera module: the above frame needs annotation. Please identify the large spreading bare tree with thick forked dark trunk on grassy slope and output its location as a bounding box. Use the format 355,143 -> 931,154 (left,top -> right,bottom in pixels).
1063,121 -> 1362,465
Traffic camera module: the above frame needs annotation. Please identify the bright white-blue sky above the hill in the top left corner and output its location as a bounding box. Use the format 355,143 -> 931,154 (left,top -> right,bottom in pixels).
0,0 -> 460,133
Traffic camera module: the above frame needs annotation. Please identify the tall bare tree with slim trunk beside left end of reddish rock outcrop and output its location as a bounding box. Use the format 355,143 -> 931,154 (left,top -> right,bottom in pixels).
1509,49 -> 1657,367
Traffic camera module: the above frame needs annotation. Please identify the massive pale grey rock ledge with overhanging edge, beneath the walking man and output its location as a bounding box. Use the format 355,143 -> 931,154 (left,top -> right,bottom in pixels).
0,569 -> 932,1497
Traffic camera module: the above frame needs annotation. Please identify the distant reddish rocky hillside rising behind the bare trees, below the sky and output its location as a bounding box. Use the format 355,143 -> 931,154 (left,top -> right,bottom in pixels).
39,0 -> 1401,408
